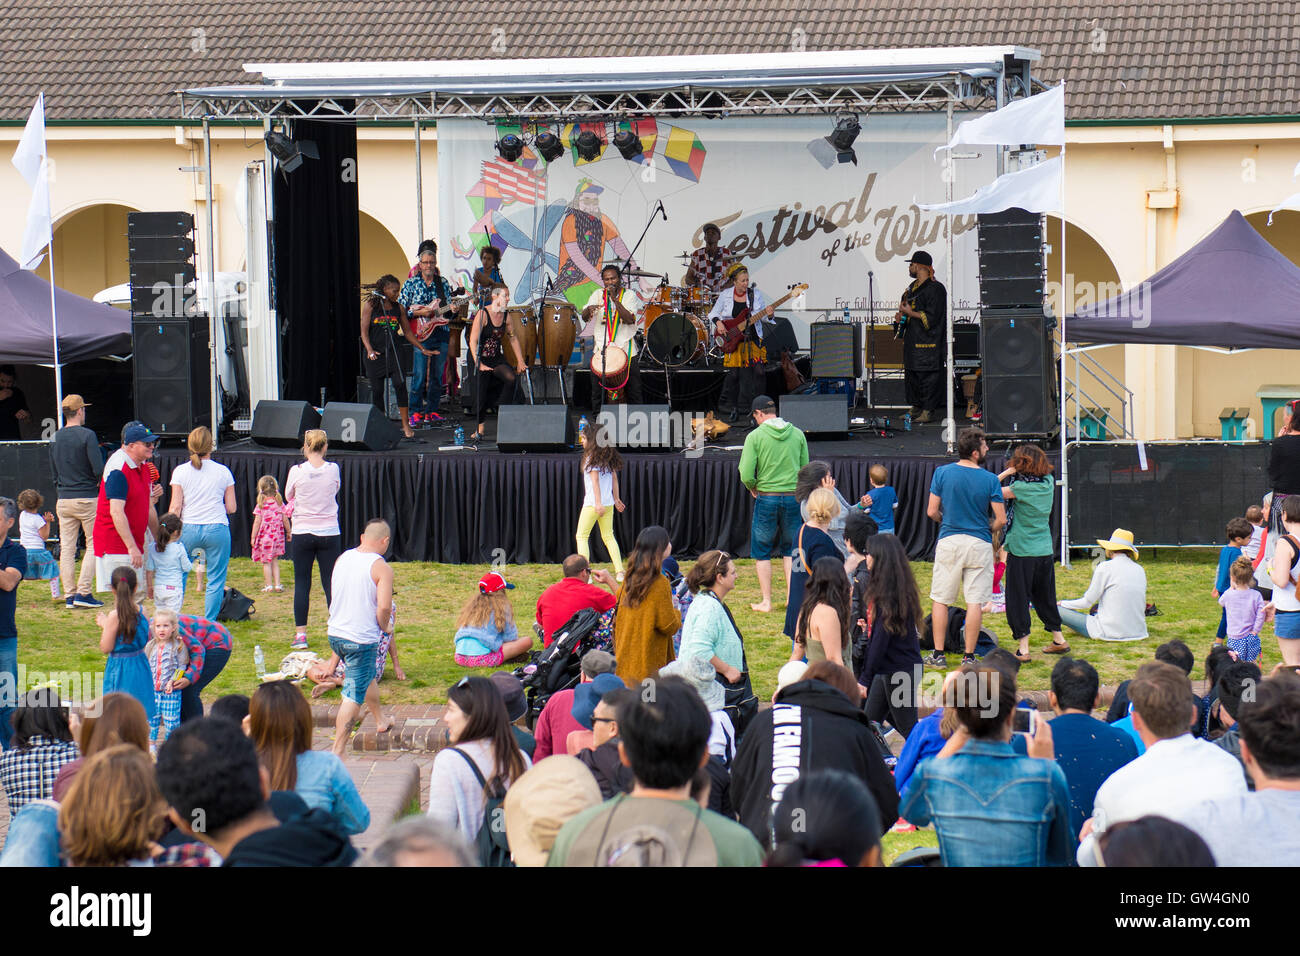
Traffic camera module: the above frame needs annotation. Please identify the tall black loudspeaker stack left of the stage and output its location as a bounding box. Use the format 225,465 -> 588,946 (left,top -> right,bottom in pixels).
126,212 -> 212,437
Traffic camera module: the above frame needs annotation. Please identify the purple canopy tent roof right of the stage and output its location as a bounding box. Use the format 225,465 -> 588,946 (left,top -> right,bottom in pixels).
1066,209 -> 1300,349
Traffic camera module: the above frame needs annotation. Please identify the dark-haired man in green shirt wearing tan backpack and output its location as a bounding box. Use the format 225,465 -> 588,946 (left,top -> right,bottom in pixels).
546,671 -> 763,866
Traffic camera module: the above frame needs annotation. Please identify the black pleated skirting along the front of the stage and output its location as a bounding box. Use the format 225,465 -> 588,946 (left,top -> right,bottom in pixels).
156,446 -> 1060,564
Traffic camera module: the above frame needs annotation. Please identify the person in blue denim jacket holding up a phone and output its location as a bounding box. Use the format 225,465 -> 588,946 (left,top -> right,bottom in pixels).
902,663 -> 1075,866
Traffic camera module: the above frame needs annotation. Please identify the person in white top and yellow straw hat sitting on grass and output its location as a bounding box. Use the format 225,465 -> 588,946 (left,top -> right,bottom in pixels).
1057,528 -> 1147,641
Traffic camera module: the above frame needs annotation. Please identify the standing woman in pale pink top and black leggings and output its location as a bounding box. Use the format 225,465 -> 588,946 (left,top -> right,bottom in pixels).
285,428 -> 342,650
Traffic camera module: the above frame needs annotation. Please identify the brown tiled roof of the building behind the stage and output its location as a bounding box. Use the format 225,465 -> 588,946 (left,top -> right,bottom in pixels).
0,0 -> 1300,121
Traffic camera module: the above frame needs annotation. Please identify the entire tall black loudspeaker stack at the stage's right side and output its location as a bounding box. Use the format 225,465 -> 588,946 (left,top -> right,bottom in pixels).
979,209 -> 1056,437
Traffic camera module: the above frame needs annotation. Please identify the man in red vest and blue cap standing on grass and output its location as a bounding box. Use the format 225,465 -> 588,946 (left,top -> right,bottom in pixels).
95,423 -> 159,601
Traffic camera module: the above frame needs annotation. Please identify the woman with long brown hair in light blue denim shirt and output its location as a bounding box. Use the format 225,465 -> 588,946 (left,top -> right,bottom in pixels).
247,680 -> 371,834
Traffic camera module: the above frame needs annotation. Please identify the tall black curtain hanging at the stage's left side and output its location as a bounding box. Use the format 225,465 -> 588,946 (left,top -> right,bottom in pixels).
274,111 -> 358,405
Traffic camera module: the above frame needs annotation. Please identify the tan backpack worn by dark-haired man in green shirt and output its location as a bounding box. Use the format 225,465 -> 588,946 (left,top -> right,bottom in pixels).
564,796 -> 718,866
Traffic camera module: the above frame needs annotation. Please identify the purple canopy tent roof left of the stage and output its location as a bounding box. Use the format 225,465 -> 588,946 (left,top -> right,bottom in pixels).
0,244 -> 131,365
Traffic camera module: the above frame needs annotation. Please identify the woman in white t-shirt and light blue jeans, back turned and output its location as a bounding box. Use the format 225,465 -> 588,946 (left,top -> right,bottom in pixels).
168,425 -> 237,620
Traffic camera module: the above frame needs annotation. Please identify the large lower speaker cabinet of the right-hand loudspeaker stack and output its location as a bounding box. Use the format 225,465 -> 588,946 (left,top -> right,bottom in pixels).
980,310 -> 1057,436
